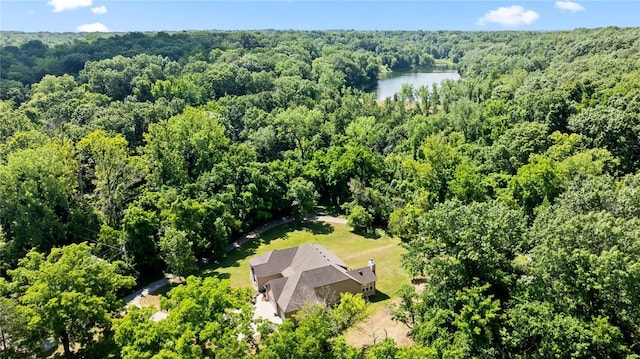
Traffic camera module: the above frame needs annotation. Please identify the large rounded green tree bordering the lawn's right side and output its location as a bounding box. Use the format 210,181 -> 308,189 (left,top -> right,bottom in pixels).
405,201 -> 526,299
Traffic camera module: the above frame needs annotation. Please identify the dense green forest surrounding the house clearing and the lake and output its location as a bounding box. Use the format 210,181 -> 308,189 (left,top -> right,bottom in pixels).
0,28 -> 640,358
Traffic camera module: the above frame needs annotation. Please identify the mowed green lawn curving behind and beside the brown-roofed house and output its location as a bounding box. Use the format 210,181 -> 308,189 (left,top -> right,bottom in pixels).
202,222 -> 410,311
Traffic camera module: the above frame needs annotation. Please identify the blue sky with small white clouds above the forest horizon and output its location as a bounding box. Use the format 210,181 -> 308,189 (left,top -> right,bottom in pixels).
0,0 -> 640,32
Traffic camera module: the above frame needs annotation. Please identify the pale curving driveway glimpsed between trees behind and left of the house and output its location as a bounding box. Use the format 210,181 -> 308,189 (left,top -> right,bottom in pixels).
124,214 -> 347,307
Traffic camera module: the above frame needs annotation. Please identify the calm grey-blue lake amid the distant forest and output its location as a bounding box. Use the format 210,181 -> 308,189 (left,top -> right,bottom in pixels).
375,70 -> 460,100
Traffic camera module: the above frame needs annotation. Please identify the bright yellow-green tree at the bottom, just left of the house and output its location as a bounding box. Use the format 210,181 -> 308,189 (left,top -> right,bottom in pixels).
114,276 -> 254,359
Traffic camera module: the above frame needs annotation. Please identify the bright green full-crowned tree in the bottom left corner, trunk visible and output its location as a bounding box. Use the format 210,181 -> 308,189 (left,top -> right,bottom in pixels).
9,243 -> 135,358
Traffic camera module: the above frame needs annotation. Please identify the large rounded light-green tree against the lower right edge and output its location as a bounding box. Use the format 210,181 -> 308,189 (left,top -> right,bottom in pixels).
522,211 -> 640,350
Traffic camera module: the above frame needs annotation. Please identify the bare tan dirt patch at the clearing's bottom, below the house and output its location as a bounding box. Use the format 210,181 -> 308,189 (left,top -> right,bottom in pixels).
344,300 -> 413,348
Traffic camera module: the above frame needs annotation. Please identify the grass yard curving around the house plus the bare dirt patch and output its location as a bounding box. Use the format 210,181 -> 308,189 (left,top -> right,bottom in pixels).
145,222 -> 412,348
